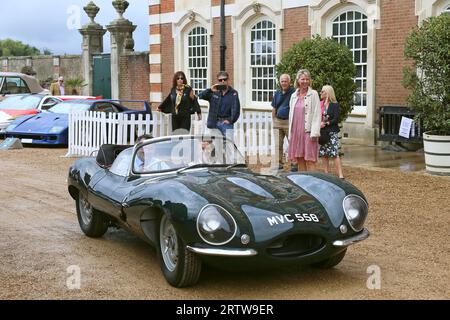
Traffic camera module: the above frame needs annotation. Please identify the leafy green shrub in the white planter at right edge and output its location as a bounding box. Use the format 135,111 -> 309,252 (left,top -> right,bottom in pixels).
403,14 -> 450,135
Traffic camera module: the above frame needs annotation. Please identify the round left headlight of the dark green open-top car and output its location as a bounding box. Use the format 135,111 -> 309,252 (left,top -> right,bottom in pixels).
197,204 -> 237,246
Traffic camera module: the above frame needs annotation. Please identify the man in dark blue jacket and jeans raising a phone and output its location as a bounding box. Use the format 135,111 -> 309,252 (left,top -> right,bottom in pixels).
198,71 -> 241,136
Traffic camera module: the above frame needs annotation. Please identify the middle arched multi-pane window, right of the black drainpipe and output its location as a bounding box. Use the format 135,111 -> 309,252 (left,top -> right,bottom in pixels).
249,20 -> 277,103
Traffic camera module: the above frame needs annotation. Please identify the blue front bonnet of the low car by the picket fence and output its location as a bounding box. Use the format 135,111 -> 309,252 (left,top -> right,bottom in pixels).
8,112 -> 68,133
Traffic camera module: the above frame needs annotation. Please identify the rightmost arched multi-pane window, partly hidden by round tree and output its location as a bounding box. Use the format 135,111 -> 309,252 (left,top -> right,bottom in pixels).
332,11 -> 367,113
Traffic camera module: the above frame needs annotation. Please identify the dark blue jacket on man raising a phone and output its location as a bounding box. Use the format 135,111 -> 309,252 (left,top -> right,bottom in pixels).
198,87 -> 241,129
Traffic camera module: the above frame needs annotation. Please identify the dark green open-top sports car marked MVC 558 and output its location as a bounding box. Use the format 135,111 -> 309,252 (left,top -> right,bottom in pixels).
68,136 -> 369,287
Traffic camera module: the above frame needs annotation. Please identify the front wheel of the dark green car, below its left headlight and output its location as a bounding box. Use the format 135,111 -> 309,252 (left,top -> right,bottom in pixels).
159,214 -> 202,288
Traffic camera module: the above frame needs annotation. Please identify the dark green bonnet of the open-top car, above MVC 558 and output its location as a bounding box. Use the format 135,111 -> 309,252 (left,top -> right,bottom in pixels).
174,169 -> 347,227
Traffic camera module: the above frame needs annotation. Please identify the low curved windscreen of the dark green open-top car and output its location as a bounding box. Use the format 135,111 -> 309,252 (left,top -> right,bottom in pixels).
133,137 -> 245,173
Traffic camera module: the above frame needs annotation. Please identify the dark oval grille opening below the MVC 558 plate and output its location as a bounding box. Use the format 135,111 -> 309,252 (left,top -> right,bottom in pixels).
266,234 -> 325,258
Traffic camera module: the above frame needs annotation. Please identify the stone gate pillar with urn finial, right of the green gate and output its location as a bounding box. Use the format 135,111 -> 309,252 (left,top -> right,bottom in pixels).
106,0 -> 136,99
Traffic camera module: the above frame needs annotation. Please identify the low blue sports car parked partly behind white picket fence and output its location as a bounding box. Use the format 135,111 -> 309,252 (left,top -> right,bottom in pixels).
5,100 -> 151,145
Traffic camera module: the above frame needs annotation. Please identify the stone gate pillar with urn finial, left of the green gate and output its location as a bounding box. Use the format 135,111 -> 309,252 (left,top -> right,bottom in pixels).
78,1 -> 106,96
